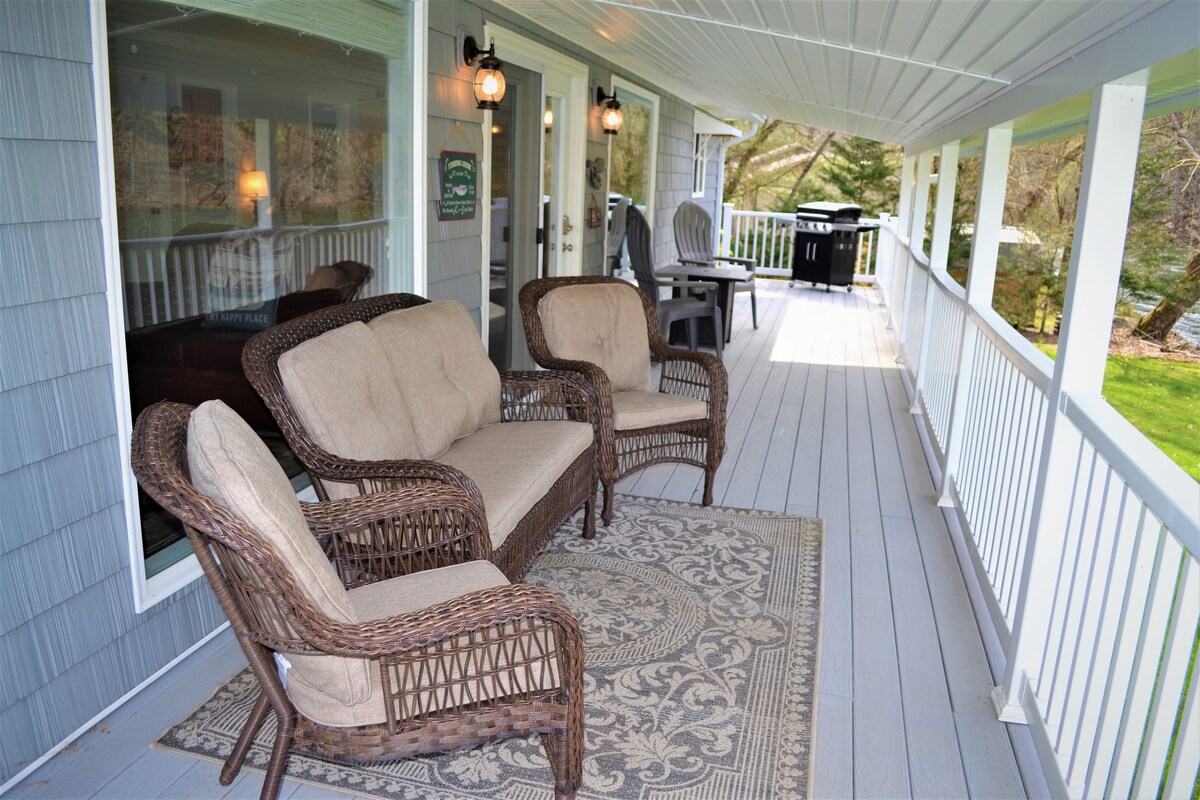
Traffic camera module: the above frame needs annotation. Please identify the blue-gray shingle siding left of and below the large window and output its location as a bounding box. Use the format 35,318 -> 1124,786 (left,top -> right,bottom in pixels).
0,0 -> 224,783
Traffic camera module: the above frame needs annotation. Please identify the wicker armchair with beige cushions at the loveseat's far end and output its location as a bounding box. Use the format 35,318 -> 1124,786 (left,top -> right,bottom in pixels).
521,277 -> 728,525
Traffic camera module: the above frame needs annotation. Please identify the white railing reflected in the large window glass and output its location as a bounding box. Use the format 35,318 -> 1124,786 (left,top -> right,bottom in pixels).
120,219 -> 388,330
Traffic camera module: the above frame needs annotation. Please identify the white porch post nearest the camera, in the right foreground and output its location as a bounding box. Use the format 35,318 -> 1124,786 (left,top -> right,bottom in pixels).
992,76 -> 1146,722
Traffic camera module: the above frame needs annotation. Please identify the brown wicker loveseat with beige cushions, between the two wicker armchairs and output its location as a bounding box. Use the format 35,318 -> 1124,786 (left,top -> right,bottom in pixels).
242,294 -> 596,581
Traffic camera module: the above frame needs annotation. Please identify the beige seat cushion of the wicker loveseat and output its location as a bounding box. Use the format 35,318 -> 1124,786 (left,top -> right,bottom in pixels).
434,421 -> 592,549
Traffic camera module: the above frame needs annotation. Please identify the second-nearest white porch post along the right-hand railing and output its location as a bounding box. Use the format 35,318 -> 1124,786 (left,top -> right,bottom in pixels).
934,122 -> 1013,506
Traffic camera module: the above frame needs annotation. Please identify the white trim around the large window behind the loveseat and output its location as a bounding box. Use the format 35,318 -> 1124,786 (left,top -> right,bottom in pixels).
97,0 -> 428,614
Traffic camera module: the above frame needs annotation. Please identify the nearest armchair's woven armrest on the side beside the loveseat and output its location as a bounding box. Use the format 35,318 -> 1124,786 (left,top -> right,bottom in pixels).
301,483 -> 492,589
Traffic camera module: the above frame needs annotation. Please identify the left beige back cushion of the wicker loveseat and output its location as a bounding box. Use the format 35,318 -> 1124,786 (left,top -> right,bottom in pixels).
280,323 -> 424,498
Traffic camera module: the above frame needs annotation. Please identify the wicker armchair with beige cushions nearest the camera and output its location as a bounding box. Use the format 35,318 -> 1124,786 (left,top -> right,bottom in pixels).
132,401 -> 583,800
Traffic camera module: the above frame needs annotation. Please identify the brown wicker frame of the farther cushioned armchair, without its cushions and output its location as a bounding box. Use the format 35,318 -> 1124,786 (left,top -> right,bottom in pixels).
520,276 -> 728,525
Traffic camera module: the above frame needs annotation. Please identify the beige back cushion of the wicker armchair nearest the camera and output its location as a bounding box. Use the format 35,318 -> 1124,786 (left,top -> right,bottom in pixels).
187,401 -> 371,705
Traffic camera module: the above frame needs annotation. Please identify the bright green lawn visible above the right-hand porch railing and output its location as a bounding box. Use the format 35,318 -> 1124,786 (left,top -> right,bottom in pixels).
1038,344 -> 1200,481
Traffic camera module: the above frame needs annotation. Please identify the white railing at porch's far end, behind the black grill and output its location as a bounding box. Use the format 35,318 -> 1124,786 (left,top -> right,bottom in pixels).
720,203 -> 878,283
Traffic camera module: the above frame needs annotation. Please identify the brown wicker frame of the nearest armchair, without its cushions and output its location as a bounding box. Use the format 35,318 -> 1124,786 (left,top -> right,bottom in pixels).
132,403 -> 583,800
